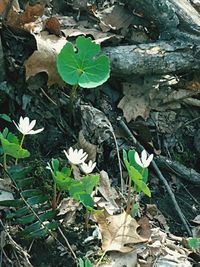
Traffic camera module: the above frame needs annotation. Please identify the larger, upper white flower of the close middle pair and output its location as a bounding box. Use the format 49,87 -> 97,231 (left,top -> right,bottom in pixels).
64,147 -> 88,165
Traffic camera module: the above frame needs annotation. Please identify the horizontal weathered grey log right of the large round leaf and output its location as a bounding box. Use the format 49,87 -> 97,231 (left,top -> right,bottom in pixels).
103,41 -> 200,79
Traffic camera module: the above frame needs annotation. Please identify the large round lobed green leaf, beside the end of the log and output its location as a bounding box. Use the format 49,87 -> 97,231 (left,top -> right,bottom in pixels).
57,36 -> 110,88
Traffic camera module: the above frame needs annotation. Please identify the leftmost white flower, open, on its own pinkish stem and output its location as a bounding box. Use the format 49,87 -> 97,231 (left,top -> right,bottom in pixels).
13,117 -> 44,135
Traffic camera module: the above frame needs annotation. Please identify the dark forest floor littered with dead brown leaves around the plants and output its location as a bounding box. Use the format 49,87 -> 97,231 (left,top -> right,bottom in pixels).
0,0 -> 200,267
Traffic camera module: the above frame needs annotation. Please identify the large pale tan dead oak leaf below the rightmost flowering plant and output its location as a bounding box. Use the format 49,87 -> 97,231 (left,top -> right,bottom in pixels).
94,212 -> 147,253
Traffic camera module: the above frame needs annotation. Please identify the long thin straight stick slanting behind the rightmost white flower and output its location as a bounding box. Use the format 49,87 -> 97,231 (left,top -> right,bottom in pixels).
118,118 -> 192,236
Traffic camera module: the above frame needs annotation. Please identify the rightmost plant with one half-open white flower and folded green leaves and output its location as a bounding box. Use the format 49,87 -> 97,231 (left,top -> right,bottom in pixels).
123,150 -> 153,215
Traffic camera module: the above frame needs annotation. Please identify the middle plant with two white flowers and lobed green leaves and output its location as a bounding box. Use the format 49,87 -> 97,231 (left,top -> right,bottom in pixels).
47,147 -> 99,210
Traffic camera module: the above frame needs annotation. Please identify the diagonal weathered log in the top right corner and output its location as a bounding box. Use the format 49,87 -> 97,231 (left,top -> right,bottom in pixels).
124,0 -> 200,36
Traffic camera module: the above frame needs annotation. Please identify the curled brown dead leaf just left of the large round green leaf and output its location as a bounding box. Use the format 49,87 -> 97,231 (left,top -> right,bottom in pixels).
25,32 -> 66,86
